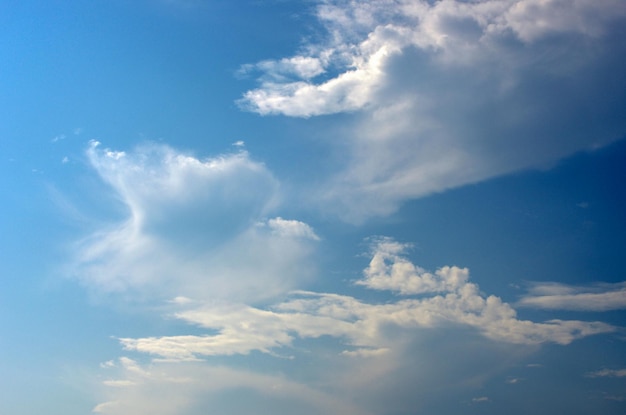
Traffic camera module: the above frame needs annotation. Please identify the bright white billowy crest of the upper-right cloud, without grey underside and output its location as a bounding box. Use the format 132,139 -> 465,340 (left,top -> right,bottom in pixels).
244,0 -> 626,117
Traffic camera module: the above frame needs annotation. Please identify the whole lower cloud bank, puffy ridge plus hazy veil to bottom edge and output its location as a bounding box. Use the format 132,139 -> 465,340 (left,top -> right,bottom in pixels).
94,238 -> 622,415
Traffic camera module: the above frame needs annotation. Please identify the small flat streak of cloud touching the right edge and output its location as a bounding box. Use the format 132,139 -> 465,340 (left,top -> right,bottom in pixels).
518,282 -> 626,311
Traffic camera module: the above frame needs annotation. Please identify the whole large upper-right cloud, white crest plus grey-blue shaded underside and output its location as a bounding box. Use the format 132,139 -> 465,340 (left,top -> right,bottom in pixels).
239,0 -> 626,222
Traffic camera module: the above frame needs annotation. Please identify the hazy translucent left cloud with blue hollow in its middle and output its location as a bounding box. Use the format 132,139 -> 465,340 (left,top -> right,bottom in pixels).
70,142 -> 317,303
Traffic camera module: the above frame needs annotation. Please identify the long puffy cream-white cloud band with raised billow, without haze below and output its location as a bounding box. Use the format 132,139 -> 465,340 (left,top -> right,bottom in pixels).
114,239 -> 615,360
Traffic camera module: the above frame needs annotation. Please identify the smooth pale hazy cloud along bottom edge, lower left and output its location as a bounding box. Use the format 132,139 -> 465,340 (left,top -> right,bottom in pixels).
93,358 -> 368,415
